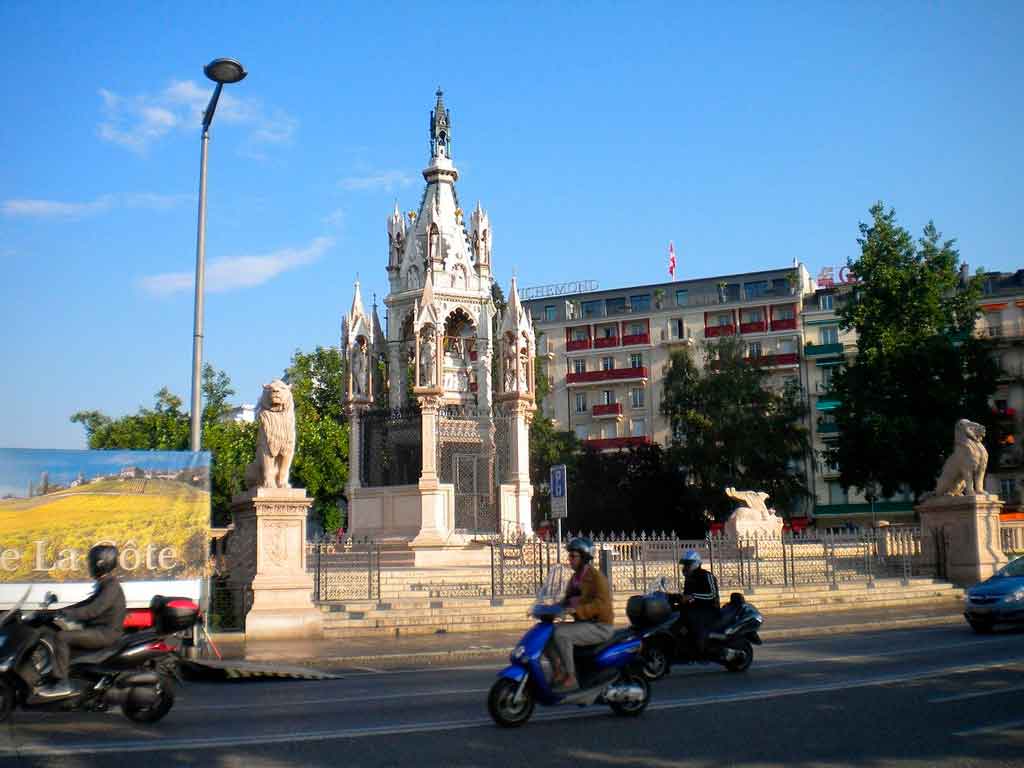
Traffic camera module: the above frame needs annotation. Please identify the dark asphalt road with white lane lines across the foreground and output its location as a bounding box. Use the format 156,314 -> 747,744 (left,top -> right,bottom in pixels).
0,626 -> 1024,768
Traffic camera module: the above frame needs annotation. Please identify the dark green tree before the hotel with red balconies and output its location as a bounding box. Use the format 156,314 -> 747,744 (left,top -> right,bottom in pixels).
662,338 -> 808,519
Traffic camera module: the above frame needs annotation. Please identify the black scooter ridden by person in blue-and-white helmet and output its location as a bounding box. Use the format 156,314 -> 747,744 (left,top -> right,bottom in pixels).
626,580 -> 764,680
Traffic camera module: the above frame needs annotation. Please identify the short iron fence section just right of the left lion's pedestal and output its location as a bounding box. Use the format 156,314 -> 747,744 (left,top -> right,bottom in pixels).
306,538 -> 381,602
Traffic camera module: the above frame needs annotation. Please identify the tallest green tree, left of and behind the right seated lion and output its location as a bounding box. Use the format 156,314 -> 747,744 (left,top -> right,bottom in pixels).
827,203 -> 1000,498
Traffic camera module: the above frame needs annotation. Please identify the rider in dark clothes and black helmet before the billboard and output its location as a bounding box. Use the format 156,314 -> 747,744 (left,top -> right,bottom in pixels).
39,544 -> 125,697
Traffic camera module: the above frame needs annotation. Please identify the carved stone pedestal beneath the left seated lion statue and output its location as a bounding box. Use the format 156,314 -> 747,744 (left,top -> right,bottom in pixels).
229,488 -> 324,640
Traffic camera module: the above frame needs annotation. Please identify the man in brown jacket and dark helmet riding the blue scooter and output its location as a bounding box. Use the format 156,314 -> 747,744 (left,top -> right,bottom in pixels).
553,537 -> 614,692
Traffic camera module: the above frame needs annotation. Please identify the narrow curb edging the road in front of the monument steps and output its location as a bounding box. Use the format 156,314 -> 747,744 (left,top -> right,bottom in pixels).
241,613 -> 966,667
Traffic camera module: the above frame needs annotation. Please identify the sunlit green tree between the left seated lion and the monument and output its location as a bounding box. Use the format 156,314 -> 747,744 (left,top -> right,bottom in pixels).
285,347 -> 348,532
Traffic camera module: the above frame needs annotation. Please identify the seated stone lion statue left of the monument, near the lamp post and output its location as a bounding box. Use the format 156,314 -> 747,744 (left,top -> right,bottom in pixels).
246,379 -> 295,489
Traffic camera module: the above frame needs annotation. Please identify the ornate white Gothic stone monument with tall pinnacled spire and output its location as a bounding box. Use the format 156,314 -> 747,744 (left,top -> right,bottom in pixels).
342,90 -> 537,565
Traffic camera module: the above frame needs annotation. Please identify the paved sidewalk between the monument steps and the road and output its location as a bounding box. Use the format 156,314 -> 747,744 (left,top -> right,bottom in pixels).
203,603 -> 970,670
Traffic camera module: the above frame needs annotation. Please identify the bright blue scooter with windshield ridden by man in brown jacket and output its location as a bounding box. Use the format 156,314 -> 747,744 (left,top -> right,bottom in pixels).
487,568 -> 650,727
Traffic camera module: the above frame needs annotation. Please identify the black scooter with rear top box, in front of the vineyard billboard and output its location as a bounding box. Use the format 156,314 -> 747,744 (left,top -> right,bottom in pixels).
0,591 -> 200,723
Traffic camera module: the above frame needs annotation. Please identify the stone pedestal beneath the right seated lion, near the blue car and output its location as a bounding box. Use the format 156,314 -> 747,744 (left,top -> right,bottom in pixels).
914,495 -> 1007,586
